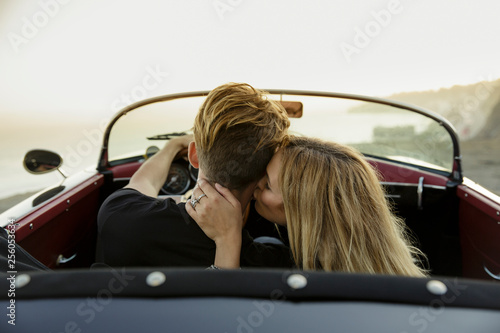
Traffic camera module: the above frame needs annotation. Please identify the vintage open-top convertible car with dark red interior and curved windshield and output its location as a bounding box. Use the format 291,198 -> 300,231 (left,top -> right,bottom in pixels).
0,90 -> 500,333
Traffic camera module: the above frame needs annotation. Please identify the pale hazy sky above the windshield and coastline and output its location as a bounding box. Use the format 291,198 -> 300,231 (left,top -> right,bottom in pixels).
0,0 -> 500,121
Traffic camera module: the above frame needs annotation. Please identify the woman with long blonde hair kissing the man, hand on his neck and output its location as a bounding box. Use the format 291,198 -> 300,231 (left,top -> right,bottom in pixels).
186,137 -> 426,276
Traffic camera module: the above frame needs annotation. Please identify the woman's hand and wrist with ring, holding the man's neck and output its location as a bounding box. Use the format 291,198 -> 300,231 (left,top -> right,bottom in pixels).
186,179 -> 243,268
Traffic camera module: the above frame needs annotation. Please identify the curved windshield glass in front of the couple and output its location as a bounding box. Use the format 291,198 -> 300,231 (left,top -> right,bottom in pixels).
108,95 -> 453,172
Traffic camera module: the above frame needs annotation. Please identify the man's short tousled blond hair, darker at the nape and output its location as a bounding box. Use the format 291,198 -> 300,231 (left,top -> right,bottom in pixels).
193,83 -> 290,190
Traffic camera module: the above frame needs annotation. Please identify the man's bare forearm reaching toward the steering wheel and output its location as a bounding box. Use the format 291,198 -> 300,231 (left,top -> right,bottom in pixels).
125,134 -> 193,198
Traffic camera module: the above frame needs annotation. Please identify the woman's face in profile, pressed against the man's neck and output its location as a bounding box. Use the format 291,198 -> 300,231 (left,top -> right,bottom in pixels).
253,151 -> 286,225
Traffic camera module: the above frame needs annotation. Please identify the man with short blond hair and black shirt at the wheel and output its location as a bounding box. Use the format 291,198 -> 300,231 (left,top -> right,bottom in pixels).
97,83 -> 293,267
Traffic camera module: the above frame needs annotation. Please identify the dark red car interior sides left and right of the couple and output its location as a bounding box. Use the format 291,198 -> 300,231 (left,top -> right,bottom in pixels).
11,154 -> 500,279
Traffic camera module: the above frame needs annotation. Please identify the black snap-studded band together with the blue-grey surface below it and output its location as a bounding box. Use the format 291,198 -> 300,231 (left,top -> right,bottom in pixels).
0,268 -> 500,333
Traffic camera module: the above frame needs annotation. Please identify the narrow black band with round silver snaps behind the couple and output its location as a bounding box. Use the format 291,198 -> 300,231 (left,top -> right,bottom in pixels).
0,267 -> 500,310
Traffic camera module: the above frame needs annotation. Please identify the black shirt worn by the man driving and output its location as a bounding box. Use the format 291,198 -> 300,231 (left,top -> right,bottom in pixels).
97,188 -> 293,267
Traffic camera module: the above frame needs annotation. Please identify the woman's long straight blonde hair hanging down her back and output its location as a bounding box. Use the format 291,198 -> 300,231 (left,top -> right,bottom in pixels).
278,137 -> 426,276
